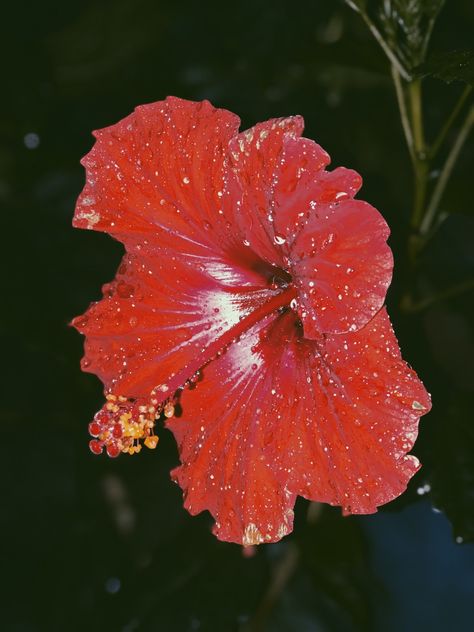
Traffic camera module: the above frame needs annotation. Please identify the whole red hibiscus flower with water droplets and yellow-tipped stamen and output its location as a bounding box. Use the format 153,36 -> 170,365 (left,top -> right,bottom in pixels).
73,98 -> 430,545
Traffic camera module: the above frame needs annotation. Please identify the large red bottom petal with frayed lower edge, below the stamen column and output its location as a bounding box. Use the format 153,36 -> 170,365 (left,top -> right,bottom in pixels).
169,310 -> 430,544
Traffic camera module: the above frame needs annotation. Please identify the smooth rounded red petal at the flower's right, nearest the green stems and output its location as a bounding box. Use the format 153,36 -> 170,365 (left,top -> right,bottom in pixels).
291,200 -> 393,338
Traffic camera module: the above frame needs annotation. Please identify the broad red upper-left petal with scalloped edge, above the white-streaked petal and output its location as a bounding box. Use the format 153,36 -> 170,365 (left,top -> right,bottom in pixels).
74,97 -> 239,252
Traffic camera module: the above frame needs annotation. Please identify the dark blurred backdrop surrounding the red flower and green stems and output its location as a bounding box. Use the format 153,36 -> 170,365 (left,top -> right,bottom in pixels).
0,0 -> 474,632
